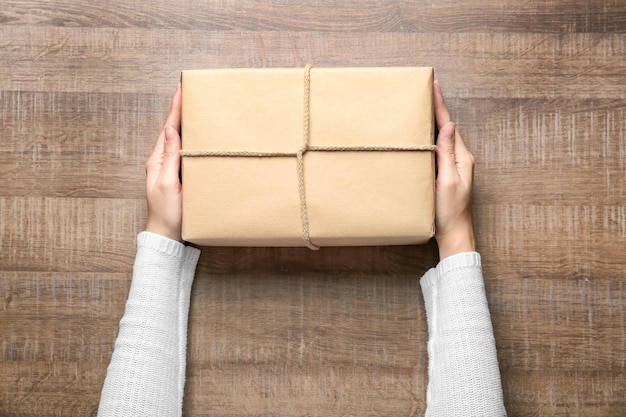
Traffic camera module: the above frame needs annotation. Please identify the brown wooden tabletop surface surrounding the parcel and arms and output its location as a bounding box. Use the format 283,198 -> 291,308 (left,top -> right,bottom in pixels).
0,0 -> 626,417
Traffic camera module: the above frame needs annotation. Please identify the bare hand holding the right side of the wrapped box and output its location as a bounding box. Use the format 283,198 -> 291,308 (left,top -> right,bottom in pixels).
434,81 -> 476,259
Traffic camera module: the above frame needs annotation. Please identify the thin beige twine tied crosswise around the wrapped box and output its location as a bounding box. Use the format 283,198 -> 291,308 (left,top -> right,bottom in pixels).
180,64 -> 437,250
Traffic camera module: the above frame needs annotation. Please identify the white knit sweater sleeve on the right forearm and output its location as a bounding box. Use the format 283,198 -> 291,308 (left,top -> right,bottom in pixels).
420,252 -> 506,417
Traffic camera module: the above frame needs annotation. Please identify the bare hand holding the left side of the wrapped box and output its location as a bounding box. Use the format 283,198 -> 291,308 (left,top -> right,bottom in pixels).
146,84 -> 182,241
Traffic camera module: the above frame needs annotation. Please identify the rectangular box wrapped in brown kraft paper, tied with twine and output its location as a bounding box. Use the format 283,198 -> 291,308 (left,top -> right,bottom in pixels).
181,67 -> 435,249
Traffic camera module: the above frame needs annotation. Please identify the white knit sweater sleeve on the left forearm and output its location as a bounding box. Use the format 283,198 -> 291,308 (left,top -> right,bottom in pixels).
98,232 -> 199,416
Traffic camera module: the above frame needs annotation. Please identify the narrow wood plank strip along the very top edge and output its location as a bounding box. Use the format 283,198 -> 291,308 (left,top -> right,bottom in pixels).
0,0 -> 626,33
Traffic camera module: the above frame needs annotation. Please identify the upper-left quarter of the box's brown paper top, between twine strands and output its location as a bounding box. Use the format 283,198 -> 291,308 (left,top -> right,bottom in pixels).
182,69 -> 304,152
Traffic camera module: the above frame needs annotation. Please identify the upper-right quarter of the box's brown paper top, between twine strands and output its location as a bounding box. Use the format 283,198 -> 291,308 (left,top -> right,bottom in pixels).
310,67 -> 433,147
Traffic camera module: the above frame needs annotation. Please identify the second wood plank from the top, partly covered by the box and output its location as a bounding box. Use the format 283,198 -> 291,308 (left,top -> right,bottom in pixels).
0,25 -> 626,99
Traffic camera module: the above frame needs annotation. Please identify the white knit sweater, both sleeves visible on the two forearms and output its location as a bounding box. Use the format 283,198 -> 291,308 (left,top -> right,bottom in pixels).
98,232 -> 506,417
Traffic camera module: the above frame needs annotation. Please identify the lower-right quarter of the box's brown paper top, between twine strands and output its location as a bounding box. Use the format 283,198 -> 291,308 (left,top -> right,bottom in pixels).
305,152 -> 433,246
